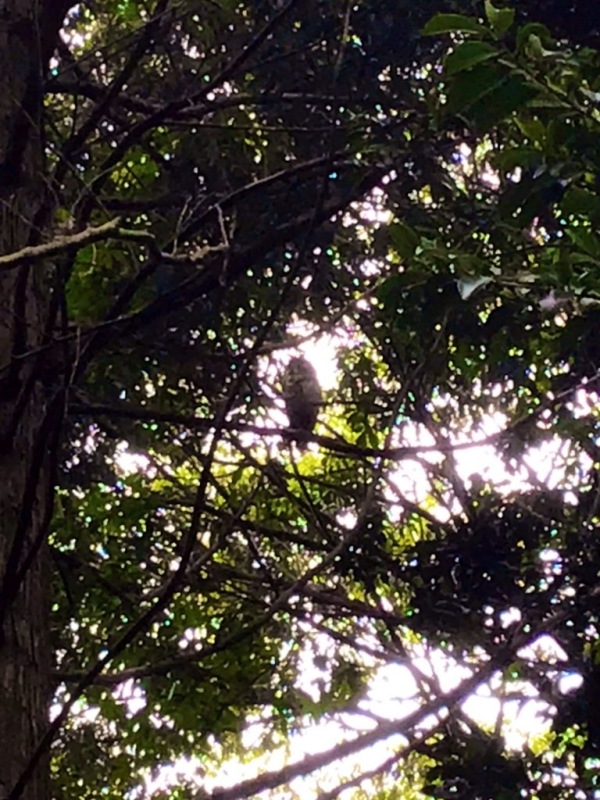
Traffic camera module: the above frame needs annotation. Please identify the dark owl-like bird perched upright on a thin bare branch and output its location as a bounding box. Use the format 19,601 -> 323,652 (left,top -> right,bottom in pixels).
282,358 -> 321,446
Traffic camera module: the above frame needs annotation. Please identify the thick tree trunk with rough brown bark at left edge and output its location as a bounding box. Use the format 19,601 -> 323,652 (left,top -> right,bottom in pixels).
0,0 -> 70,800
